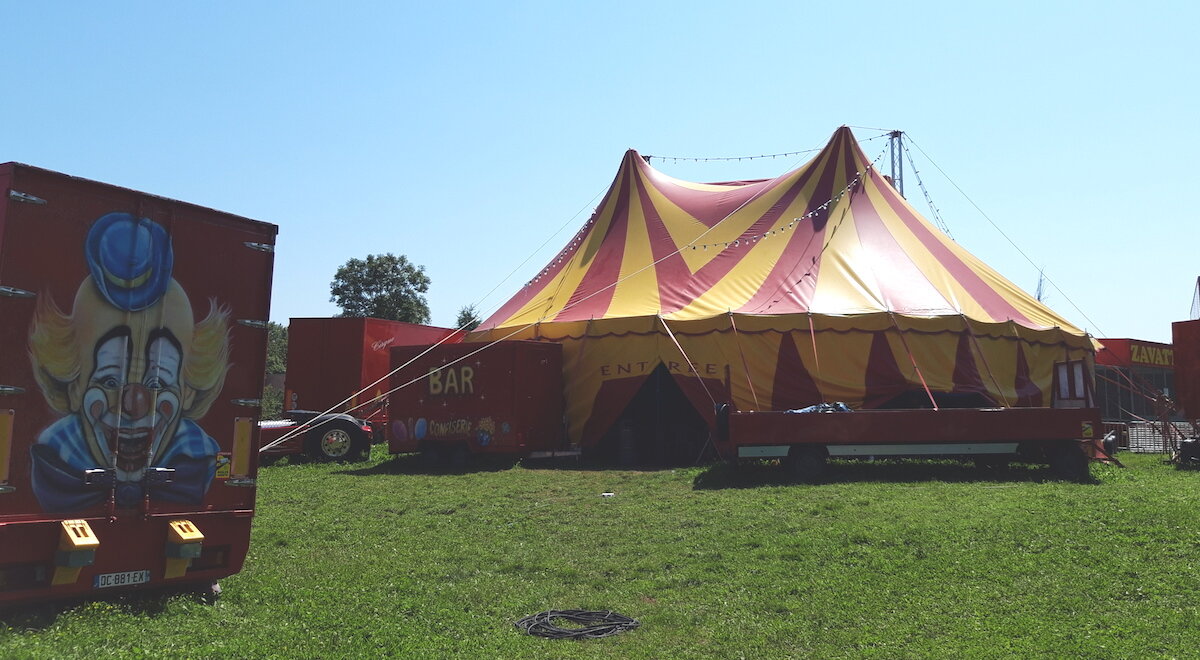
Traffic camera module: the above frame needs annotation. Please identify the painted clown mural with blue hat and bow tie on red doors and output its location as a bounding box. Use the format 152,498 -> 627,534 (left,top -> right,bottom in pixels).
29,214 -> 229,511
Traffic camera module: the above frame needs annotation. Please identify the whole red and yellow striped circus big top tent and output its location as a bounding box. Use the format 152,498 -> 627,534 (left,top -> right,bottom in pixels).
468,127 -> 1093,445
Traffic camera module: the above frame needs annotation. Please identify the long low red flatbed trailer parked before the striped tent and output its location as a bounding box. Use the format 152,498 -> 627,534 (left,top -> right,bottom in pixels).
718,404 -> 1102,481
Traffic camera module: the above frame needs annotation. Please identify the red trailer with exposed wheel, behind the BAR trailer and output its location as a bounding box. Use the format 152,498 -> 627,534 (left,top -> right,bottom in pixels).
259,318 -> 462,461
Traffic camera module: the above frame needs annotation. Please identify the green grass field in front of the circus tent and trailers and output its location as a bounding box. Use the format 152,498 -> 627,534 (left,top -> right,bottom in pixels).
0,446 -> 1200,658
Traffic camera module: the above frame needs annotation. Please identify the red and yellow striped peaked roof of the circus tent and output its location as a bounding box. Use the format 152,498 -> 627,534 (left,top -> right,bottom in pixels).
481,127 -> 1084,336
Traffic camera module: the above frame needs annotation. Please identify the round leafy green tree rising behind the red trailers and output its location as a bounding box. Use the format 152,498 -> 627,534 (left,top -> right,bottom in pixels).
329,253 -> 430,323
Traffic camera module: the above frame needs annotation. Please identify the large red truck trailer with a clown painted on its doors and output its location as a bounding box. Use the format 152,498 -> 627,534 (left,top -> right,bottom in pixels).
0,163 -> 277,605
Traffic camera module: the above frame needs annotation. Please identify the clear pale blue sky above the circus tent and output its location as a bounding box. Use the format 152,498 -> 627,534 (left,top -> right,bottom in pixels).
0,1 -> 1200,341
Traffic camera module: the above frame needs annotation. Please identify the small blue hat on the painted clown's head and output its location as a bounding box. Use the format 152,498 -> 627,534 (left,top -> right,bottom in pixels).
84,214 -> 175,312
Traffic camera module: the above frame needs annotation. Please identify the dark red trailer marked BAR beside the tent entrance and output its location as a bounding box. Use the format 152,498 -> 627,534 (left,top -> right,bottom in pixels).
388,341 -> 565,463
